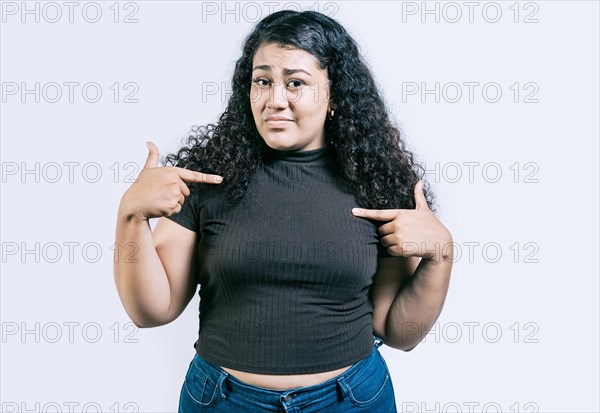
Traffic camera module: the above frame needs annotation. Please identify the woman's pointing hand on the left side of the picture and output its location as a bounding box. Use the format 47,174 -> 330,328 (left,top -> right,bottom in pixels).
120,141 -> 223,220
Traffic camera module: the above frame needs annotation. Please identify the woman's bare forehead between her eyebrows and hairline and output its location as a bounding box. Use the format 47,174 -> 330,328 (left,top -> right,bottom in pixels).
252,43 -> 321,71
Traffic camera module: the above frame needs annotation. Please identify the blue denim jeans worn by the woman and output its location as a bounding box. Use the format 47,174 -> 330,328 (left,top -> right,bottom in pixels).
179,338 -> 396,413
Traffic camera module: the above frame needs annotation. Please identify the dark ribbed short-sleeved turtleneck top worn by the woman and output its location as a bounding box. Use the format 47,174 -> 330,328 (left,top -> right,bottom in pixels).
169,145 -> 388,374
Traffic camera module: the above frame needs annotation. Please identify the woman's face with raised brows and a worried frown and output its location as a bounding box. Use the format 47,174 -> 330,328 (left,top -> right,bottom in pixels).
250,43 -> 329,151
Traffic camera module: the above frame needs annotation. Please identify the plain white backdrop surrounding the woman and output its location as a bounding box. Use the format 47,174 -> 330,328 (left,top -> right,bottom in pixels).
0,1 -> 600,412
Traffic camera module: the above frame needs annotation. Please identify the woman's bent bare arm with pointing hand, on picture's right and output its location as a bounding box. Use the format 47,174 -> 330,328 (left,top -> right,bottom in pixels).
353,181 -> 454,351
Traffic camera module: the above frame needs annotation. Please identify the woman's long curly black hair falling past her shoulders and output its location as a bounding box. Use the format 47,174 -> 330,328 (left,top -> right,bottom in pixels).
163,10 -> 436,210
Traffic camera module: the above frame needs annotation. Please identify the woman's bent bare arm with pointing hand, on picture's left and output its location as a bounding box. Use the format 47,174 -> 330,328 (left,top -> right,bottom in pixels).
114,143 -> 224,327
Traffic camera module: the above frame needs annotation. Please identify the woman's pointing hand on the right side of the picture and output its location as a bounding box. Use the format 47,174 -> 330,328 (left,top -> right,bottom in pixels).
352,180 -> 452,261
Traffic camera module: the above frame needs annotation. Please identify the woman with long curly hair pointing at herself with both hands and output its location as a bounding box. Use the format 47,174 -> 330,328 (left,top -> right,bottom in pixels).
115,10 -> 453,412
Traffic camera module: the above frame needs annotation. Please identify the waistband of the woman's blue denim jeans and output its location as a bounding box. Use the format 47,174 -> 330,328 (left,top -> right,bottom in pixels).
193,337 -> 383,408
